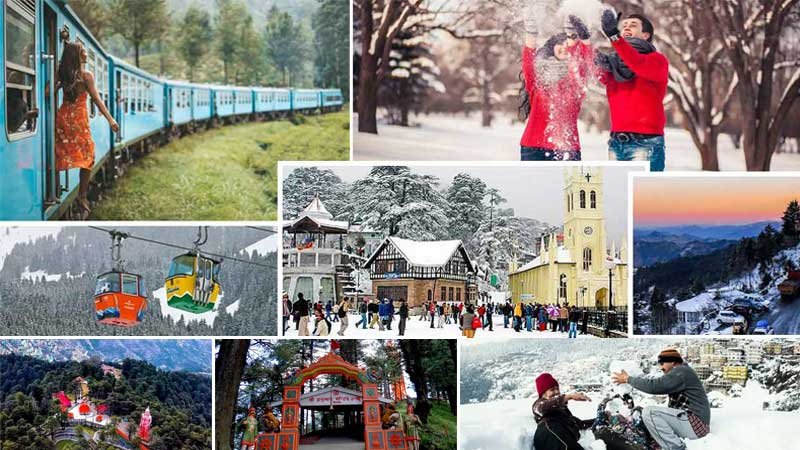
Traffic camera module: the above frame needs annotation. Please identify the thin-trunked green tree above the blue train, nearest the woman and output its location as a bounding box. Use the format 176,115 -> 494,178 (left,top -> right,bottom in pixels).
109,0 -> 169,67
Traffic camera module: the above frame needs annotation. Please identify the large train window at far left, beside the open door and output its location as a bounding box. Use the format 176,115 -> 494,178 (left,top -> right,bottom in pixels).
5,0 -> 38,136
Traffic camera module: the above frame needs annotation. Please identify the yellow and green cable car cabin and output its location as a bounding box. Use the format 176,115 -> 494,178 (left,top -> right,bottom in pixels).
165,252 -> 221,314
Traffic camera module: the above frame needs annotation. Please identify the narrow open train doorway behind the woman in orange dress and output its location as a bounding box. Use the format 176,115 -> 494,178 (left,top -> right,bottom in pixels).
42,2 -> 59,211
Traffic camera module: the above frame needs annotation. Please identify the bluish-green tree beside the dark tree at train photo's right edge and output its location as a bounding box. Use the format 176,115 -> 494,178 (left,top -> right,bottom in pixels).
264,6 -> 308,86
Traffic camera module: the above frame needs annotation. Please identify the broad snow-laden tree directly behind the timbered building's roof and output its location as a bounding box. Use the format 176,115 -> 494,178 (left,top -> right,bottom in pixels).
347,166 -> 448,240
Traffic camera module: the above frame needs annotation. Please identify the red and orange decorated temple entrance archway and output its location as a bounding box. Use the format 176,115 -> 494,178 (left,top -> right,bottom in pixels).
268,352 -> 406,450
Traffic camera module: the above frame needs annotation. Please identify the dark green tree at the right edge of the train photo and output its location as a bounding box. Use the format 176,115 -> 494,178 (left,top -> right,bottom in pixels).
313,0 -> 350,96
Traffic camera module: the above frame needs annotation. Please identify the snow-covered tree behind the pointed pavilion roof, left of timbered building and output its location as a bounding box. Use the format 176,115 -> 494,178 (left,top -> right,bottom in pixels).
283,167 -> 347,220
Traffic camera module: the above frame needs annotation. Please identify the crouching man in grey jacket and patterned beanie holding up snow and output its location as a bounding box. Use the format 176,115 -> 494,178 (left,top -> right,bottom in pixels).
611,348 -> 711,450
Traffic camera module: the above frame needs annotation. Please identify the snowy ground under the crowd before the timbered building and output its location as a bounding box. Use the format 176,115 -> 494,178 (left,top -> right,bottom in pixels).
279,314 -> 460,339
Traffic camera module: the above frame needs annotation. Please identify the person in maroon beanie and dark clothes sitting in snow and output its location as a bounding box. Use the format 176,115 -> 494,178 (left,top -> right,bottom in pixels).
531,373 -> 594,450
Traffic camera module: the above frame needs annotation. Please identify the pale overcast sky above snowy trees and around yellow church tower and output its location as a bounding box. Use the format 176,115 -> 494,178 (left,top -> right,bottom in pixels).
283,163 -> 641,241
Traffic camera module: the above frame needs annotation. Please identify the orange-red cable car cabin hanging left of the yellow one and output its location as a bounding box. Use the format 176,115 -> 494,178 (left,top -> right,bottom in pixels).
94,271 -> 147,327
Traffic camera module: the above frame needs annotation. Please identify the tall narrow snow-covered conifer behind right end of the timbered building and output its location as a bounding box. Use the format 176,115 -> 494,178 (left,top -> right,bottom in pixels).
445,173 -> 487,241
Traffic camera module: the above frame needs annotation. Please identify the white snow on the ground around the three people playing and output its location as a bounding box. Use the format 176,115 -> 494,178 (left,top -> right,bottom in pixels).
458,381 -> 800,450
